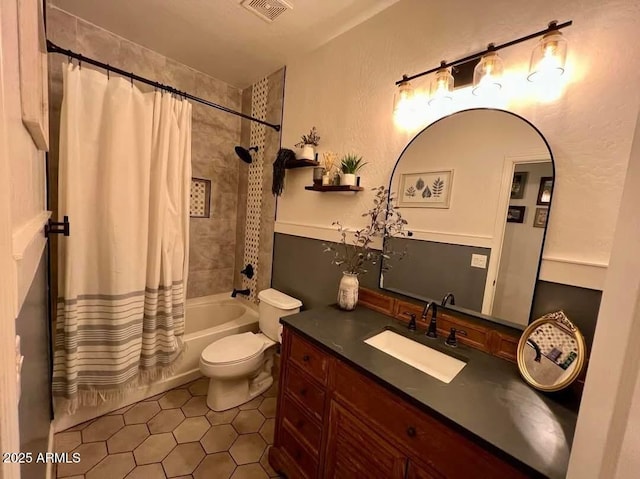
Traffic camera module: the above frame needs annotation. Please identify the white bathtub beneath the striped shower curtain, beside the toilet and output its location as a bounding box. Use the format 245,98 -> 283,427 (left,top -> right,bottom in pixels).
53,293 -> 258,432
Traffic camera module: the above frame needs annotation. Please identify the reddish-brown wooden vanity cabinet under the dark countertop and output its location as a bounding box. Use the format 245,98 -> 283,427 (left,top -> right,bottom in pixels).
269,327 -> 527,479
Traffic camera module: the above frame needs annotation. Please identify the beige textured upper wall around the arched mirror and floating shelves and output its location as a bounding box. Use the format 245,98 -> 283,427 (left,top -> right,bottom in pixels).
276,0 -> 640,289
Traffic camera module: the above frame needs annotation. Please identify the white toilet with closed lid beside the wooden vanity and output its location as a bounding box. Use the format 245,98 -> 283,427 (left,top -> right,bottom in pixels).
200,289 -> 302,411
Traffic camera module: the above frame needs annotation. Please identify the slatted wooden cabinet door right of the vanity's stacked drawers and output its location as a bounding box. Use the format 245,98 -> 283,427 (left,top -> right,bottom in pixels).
324,401 -> 406,479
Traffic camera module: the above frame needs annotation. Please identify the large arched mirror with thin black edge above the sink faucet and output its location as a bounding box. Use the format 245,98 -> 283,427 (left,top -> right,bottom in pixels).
380,109 -> 554,329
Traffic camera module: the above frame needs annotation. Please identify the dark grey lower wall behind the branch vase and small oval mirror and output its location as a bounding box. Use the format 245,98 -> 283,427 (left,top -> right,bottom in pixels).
272,233 -> 602,349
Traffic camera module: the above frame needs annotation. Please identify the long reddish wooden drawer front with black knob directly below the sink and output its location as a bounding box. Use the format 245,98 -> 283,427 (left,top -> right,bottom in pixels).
335,363 -> 526,478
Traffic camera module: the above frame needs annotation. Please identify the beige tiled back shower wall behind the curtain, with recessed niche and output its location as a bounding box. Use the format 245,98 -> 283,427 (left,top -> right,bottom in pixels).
47,7 -> 244,297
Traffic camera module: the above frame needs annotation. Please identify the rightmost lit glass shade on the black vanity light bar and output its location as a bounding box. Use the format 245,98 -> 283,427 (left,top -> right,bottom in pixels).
527,22 -> 567,82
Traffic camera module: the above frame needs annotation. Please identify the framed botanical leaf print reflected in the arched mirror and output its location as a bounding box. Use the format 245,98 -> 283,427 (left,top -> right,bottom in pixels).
398,170 -> 453,208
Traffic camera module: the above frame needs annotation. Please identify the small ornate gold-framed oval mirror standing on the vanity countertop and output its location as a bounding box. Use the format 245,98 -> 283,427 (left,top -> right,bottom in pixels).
517,311 -> 586,392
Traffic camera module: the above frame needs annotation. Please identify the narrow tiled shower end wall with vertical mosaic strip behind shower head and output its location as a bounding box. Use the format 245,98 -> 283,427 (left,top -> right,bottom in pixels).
235,68 -> 285,299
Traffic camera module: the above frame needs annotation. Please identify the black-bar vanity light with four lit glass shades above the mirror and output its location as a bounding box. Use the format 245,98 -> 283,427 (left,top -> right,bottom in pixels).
394,20 -> 573,107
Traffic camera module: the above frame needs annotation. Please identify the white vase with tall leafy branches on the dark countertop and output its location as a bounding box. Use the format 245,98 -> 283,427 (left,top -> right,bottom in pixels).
324,186 -> 407,311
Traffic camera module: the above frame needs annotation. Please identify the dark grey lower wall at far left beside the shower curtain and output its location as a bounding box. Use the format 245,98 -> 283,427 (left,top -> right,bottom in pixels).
16,254 -> 51,479
